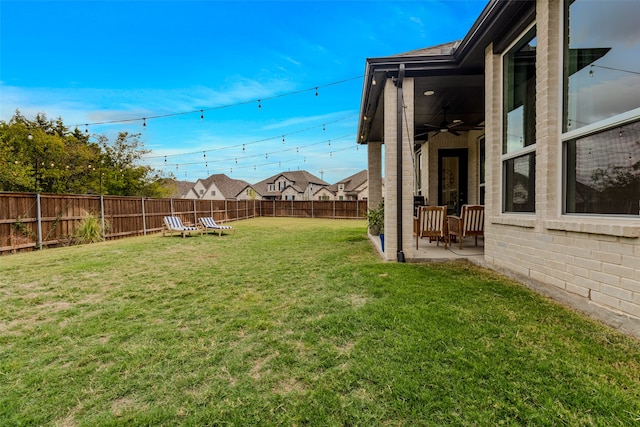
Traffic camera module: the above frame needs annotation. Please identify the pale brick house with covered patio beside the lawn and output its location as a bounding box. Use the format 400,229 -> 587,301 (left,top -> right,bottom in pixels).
358,0 -> 640,333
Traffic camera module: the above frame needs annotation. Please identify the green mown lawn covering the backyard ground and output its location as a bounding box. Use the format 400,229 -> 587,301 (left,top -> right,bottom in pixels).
0,218 -> 640,426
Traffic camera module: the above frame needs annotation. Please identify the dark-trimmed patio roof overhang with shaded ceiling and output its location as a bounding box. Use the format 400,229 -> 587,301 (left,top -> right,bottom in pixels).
357,0 -> 535,144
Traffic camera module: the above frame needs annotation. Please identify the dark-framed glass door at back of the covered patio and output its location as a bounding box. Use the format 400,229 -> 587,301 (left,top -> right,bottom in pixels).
438,148 -> 468,215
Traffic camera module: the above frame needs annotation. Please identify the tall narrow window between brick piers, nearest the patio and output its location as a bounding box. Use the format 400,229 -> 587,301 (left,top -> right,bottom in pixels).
502,28 -> 536,212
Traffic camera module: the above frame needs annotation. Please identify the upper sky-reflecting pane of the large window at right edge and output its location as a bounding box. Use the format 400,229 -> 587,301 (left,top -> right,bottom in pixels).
563,0 -> 640,132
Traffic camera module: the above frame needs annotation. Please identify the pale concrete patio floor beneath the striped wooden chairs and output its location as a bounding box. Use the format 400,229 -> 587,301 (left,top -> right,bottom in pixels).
369,235 -> 484,262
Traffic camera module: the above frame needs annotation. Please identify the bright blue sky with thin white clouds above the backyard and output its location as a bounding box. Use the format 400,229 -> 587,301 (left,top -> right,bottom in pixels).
0,0 -> 486,183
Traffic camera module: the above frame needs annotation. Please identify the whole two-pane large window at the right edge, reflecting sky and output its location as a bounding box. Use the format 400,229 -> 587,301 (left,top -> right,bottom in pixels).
563,0 -> 640,216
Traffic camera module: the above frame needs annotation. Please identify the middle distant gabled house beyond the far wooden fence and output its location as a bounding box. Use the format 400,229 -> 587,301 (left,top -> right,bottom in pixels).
253,171 -> 329,200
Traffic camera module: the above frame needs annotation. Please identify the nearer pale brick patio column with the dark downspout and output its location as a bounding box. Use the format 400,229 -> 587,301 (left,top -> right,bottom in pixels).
384,74 -> 415,260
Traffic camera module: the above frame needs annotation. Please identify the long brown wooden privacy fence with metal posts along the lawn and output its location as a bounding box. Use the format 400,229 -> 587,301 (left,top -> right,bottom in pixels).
0,193 -> 367,255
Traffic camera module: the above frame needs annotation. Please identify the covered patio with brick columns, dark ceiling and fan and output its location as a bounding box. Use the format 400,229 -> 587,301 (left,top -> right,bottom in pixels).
358,2 -> 531,262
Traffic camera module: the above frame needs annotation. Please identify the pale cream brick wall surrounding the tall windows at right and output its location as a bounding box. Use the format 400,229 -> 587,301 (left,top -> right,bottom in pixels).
485,0 -> 640,333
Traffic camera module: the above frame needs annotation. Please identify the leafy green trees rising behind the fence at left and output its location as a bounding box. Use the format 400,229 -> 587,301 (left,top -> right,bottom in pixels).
0,111 -> 172,197
